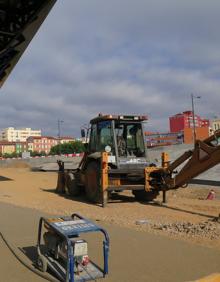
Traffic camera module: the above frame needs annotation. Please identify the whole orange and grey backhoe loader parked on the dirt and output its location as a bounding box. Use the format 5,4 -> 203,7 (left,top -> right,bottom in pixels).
57,114 -> 220,207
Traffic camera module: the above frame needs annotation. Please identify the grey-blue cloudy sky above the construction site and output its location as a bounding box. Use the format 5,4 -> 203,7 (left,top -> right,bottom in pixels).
0,0 -> 220,136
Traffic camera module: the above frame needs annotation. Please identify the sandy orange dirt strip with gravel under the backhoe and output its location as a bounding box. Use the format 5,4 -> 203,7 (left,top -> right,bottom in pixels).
0,167 -> 220,249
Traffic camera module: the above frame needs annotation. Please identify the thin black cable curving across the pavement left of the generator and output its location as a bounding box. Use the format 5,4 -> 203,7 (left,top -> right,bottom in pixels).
0,232 -> 59,282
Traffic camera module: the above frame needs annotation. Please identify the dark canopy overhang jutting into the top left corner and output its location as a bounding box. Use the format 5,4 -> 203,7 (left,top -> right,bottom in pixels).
0,0 -> 56,87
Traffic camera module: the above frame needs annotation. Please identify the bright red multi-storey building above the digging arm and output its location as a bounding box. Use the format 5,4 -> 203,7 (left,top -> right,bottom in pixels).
169,111 -> 210,132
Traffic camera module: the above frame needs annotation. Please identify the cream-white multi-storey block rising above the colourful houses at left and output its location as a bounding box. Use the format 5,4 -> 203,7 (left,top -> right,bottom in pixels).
0,127 -> 41,142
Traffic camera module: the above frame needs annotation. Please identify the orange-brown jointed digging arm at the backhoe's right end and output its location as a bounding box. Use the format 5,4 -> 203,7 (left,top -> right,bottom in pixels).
150,130 -> 220,190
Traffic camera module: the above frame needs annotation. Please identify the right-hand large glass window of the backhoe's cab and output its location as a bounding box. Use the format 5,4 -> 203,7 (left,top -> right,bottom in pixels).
115,121 -> 145,157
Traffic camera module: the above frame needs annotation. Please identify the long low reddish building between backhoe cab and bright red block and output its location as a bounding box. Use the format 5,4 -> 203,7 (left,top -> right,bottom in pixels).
145,132 -> 183,147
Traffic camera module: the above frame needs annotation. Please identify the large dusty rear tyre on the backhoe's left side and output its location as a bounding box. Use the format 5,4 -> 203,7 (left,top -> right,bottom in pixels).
85,161 -> 102,204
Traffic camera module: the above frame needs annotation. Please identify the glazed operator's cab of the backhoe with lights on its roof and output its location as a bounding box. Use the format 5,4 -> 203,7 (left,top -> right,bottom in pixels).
88,114 -> 147,168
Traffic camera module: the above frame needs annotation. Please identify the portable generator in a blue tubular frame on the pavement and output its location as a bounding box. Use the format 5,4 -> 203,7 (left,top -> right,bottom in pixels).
37,214 -> 109,282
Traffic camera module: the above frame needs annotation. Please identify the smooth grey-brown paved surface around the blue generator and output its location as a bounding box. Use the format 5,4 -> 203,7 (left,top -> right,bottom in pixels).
0,203 -> 220,282
